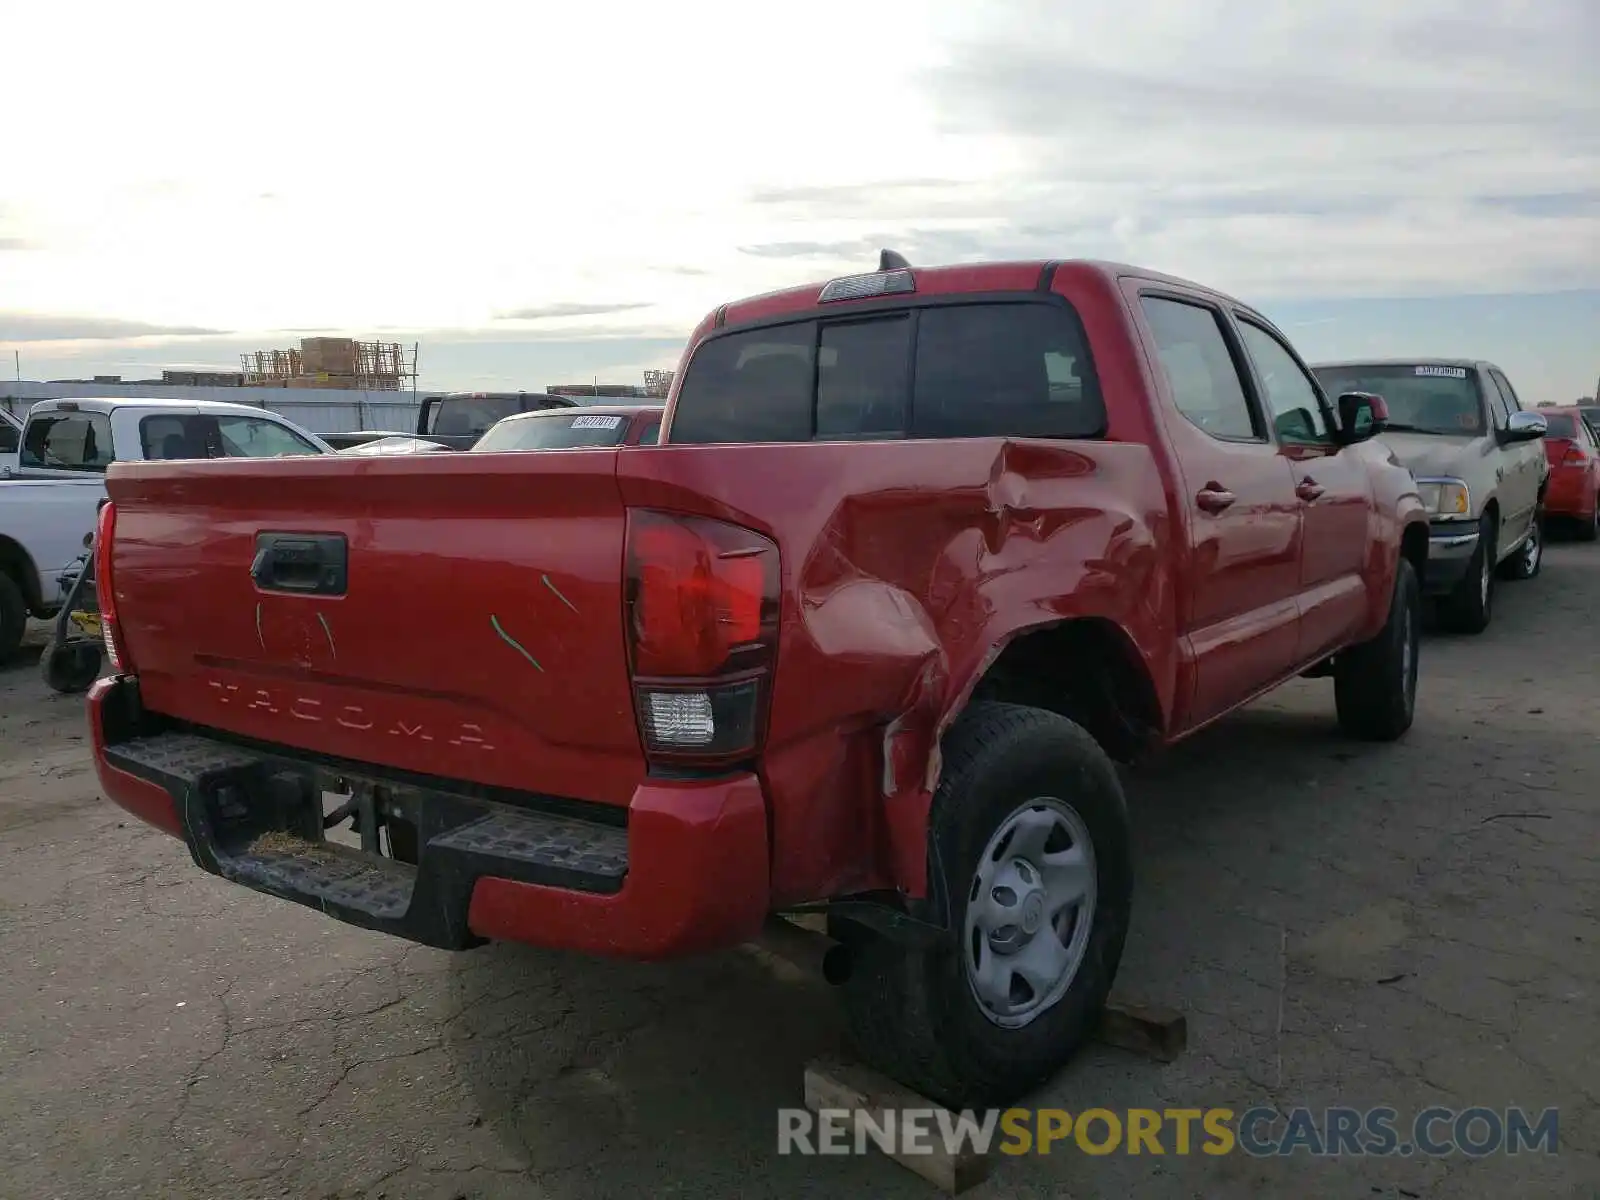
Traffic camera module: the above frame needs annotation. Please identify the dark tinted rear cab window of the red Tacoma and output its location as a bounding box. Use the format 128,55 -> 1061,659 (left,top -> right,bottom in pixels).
670,302 -> 1106,443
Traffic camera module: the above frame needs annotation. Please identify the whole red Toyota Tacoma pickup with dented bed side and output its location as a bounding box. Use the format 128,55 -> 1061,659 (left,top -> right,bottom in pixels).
88,254 -> 1429,1106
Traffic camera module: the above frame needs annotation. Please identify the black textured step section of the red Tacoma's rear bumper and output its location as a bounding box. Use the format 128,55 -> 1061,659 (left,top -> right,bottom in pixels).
106,733 -> 627,949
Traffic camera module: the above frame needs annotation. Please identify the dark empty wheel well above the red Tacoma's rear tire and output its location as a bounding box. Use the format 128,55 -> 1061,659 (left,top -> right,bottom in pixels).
973,618 -> 1163,762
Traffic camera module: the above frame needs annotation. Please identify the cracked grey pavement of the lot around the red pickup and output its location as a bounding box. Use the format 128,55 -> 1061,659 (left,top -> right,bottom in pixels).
0,546 -> 1600,1200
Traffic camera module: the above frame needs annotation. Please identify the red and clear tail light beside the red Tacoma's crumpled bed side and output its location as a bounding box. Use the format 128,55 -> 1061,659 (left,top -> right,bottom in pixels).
627,509 -> 779,763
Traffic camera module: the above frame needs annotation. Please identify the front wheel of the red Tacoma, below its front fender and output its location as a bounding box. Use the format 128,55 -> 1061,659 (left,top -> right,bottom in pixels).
1333,557 -> 1422,742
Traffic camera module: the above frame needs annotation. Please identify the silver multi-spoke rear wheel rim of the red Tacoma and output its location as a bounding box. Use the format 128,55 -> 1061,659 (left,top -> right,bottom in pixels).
963,797 -> 1096,1029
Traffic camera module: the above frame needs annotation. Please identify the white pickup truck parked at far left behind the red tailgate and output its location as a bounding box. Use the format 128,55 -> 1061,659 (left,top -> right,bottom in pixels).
0,398 -> 333,659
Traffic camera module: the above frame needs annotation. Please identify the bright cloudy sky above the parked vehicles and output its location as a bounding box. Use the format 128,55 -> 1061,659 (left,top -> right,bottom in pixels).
0,0 -> 1600,403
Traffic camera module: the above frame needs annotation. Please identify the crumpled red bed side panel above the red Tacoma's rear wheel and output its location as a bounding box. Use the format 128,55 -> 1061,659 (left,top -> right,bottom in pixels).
619,438 -> 1176,906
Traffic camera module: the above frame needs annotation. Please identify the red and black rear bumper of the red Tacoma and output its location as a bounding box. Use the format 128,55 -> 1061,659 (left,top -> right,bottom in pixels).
88,678 -> 770,958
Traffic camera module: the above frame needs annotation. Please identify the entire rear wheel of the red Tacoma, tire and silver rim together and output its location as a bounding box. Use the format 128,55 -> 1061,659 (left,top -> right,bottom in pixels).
843,702 -> 1133,1109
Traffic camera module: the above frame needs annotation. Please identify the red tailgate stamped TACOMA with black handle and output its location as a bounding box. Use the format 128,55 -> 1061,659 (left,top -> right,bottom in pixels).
107,450 -> 645,805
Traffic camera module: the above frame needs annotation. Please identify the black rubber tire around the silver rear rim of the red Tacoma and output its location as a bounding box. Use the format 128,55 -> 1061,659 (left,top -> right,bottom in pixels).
843,702 -> 1133,1109
